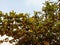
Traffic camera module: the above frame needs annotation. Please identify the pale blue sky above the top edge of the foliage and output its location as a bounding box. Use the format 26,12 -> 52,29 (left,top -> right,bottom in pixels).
0,0 -> 56,13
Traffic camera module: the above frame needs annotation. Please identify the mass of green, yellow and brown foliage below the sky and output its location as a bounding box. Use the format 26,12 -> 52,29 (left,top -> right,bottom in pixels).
0,1 -> 60,45
